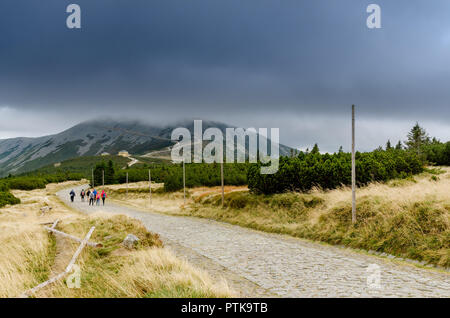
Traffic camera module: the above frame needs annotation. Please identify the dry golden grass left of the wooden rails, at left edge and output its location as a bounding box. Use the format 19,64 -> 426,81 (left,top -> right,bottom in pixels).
0,184 -> 76,297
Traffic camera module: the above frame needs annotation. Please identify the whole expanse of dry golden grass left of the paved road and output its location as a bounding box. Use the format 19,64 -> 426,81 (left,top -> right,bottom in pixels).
0,182 -> 235,297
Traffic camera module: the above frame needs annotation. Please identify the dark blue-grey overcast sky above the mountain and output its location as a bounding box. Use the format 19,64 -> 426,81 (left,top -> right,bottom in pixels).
0,0 -> 450,151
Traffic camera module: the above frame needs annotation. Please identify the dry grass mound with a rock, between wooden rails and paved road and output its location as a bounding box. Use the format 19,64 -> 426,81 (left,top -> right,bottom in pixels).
37,213 -> 234,298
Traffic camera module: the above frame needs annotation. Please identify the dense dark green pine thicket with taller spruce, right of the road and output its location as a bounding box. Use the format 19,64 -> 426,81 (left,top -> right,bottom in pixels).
248,123 -> 450,194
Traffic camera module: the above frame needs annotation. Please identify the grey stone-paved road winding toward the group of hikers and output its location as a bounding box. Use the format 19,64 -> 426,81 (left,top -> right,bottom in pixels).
57,187 -> 450,297
